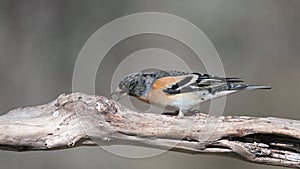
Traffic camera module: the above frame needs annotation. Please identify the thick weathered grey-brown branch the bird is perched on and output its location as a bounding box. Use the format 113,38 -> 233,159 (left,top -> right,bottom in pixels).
0,93 -> 300,168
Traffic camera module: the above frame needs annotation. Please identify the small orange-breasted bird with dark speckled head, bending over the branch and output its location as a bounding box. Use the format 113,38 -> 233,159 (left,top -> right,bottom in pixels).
111,70 -> 271,117
